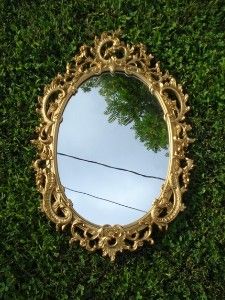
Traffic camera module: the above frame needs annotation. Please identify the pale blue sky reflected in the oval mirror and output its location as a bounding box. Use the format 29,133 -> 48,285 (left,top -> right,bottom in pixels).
57,74 -> 168,225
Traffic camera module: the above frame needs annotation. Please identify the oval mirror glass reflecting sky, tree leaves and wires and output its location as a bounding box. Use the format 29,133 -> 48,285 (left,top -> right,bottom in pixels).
57,73 -> 169,225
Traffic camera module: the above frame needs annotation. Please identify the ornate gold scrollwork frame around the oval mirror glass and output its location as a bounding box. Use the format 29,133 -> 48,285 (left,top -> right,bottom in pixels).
32,31 -> 193,261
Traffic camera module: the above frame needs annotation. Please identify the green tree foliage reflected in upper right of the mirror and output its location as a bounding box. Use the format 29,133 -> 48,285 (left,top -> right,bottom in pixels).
82,74 -> 168,152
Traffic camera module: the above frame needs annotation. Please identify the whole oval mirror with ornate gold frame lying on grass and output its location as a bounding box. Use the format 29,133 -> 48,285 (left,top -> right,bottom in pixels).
32,32 -> 193,260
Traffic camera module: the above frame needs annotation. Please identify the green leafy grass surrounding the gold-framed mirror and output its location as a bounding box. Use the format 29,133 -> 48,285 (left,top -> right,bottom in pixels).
0,0 -> 225,300
